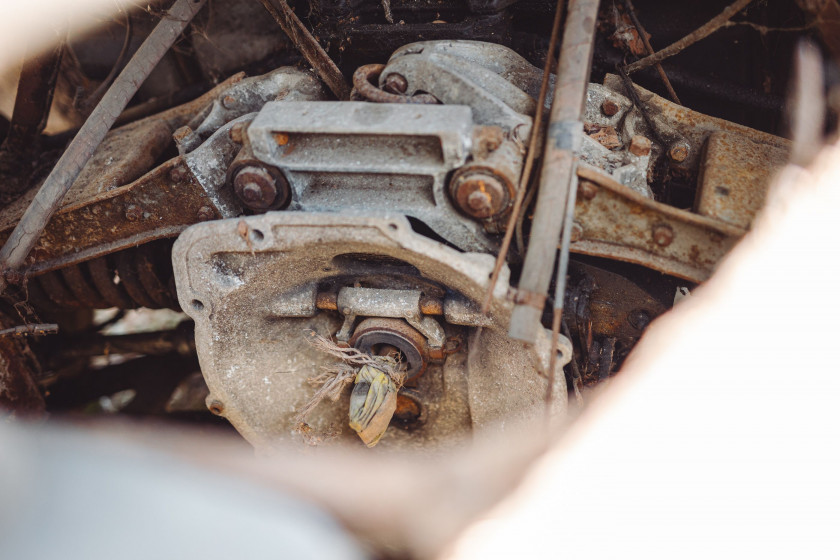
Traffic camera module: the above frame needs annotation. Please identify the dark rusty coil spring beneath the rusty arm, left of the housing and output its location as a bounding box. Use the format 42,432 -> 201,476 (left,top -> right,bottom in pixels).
28,240 -> 180,311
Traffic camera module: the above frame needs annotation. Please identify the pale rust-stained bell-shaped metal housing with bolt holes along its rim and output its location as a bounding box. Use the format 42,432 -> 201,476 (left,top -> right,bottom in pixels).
173,212 -> 571,449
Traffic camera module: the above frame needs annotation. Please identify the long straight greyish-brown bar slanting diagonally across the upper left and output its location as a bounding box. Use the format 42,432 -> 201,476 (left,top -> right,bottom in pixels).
0,0 -> 207,293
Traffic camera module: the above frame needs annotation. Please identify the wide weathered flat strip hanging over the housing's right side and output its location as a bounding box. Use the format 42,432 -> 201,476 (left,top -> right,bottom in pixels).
508,0 -> 598,344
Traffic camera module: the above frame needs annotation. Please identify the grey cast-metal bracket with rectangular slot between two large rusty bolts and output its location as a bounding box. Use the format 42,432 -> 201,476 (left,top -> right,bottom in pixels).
248,101 -> 495,252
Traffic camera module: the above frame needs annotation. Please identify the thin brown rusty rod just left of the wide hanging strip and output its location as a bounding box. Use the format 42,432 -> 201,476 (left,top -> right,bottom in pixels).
481,0 -> 564,313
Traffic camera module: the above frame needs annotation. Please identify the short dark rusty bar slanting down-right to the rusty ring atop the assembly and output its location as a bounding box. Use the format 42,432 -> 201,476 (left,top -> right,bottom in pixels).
260,0 -> 350,100
